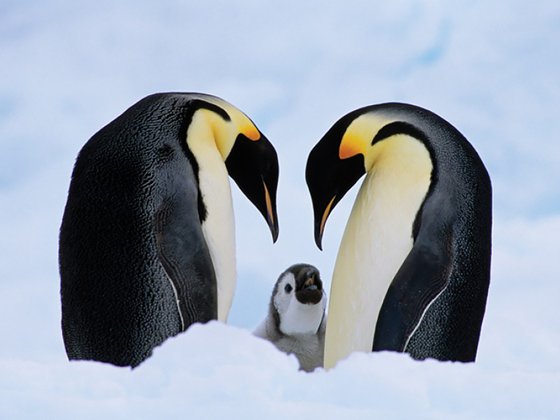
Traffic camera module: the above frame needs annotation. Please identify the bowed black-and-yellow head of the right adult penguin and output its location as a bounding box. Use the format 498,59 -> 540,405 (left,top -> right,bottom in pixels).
306,103 -> 429,249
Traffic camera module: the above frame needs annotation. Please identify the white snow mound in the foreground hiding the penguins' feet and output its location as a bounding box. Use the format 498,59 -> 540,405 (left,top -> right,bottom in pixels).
0,322 -> 560,419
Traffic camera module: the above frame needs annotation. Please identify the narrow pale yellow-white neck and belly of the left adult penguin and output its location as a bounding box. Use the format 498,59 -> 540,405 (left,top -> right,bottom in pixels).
187,112 -> 236,322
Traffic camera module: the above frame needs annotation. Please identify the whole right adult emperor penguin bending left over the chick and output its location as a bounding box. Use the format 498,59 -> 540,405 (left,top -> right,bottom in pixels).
306,103 -> 492,368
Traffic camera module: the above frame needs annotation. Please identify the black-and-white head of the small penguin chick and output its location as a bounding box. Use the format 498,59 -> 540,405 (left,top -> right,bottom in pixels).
270,264 -> 326,335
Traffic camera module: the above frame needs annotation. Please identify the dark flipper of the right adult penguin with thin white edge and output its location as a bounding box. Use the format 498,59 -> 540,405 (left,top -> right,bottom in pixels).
372,235 -> 451,357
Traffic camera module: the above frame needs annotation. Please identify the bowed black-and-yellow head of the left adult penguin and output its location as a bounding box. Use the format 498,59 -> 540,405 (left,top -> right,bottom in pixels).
191,94 -> 279,242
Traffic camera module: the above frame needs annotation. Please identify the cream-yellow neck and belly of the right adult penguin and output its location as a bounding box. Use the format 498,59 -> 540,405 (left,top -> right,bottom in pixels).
325,135 -> 433,367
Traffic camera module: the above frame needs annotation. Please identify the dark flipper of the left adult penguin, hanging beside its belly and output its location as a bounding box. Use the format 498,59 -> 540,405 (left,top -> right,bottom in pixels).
154,194 -> 218,331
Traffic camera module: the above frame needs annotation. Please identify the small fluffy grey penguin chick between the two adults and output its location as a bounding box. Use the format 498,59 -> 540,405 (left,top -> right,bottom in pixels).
254,264 -> 327,372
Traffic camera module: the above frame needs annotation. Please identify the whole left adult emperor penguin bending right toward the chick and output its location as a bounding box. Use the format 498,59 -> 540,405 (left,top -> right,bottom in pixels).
59,93 -> 278,367
